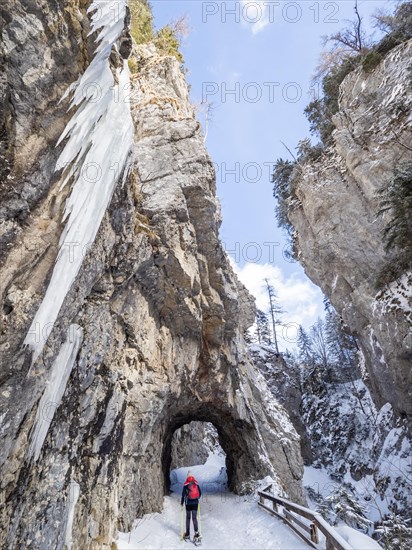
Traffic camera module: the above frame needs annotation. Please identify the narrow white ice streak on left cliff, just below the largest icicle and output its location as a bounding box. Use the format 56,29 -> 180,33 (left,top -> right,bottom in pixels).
28,325 -> 83,461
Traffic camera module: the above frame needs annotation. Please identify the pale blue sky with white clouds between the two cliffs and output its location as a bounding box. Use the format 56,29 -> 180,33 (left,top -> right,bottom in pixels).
151,0 -> 393,349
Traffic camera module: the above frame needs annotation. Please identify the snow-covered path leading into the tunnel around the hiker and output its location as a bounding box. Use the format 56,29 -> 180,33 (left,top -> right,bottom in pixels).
116,454 -> 309,550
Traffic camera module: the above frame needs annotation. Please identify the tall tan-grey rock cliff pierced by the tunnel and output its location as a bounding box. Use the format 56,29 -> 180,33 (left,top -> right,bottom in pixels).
0,0 -> 303,550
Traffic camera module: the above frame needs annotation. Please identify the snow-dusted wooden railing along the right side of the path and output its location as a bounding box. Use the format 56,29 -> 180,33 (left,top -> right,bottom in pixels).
258,485 -> 353,550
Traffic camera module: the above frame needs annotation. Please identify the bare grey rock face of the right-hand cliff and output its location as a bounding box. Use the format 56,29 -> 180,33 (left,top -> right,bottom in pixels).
289,41 -> 412,415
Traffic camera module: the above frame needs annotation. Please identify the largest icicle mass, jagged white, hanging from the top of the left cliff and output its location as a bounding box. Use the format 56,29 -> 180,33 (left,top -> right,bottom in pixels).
24,0 -> 134,362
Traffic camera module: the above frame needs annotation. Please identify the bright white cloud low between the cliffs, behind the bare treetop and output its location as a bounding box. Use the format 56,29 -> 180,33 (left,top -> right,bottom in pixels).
232,261 -> 323,349
